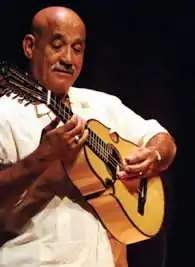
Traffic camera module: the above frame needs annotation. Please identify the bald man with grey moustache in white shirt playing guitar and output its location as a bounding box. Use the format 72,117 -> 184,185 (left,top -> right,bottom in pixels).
0,4 -> 176,267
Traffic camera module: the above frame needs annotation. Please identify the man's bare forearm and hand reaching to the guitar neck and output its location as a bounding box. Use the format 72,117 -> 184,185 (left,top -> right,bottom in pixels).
0,115 -> 88,191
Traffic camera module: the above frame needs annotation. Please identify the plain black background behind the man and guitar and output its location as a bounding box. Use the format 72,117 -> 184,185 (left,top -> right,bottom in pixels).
0,0 -> 195,267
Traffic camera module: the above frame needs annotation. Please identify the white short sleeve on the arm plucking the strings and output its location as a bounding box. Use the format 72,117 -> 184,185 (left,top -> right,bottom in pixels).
106,96 -> 168,146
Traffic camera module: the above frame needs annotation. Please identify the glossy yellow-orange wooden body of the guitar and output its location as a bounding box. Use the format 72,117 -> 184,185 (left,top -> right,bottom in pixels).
68,120 -> 164,244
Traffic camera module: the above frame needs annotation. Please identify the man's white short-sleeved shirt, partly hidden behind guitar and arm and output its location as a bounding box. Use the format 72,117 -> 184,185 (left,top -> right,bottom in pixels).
0,87 -> 166,267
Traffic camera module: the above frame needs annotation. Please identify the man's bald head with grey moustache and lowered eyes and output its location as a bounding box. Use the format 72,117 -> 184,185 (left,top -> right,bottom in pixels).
23,7 -> 86,94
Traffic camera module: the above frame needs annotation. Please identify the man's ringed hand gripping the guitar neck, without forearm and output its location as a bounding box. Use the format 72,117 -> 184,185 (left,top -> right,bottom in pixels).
38,115 -> 88,166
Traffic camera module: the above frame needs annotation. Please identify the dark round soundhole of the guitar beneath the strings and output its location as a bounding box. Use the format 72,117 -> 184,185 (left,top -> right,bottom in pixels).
106,144 -> 122,187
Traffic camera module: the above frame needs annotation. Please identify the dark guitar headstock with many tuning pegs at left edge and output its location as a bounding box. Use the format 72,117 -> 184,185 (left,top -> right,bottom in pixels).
0,61 -> 47,105
